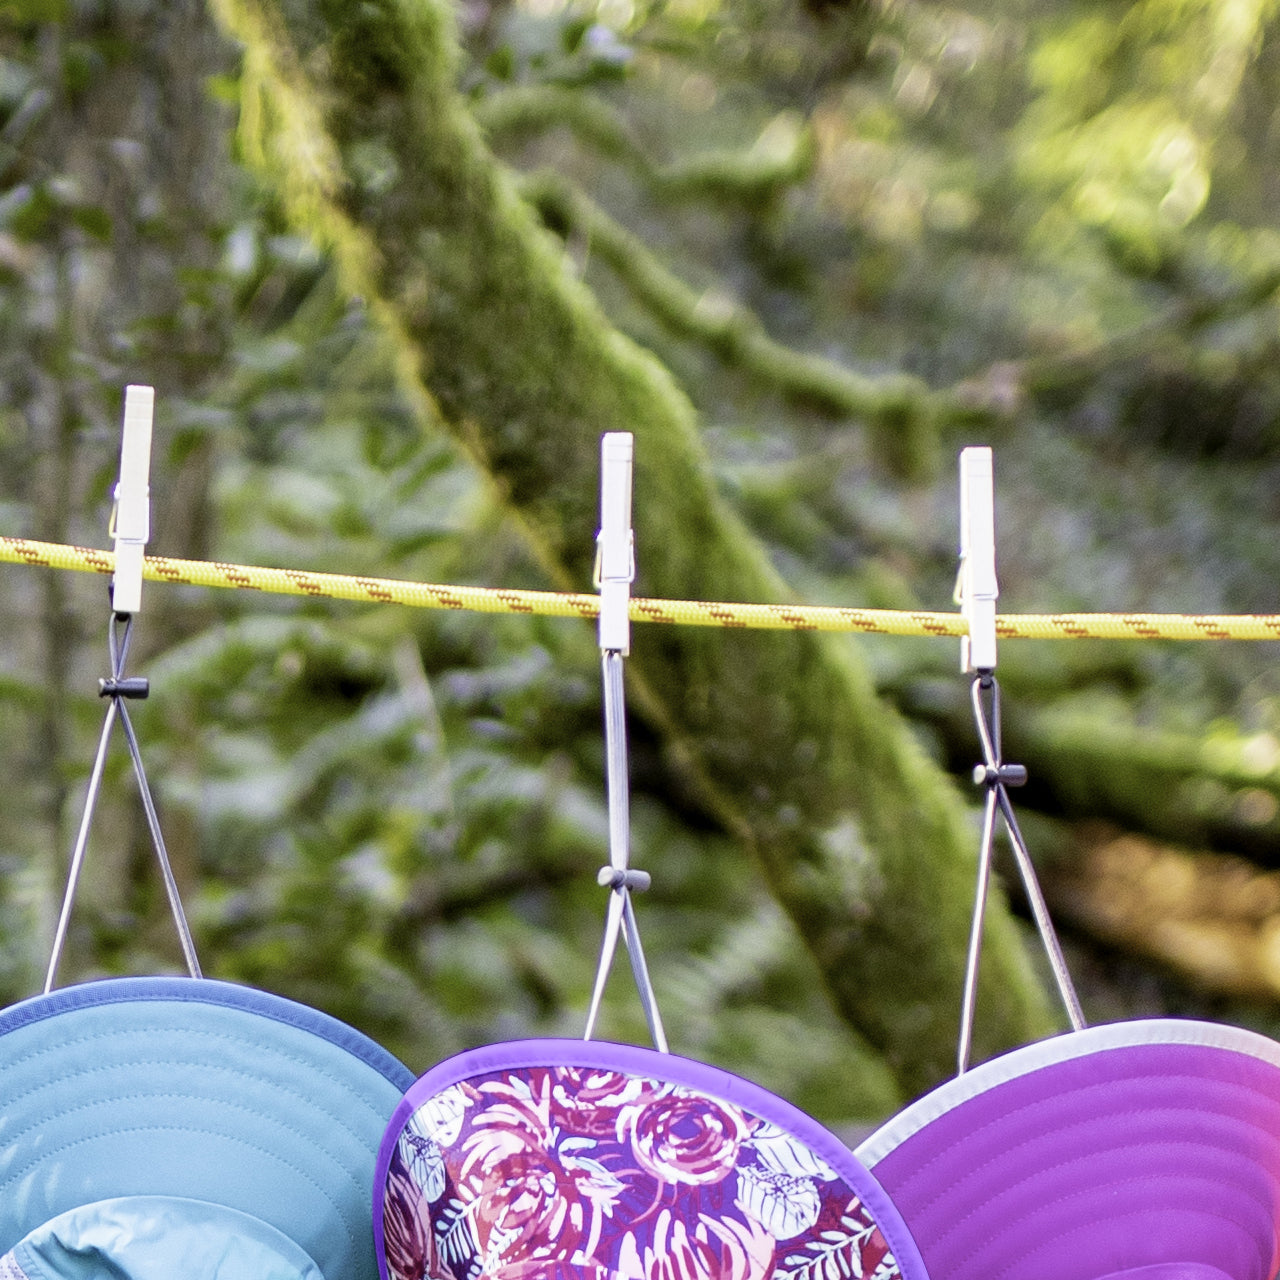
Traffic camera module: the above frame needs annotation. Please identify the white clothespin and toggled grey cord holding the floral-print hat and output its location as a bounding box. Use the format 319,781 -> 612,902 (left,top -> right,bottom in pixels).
582,431 -> 667,1052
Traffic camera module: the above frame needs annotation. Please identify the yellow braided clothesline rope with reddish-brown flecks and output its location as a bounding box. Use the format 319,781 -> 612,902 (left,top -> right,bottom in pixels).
0,536 -> 1280,640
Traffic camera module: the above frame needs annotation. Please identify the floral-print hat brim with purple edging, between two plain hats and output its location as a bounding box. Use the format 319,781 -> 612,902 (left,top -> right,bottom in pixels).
374,1039 -> 926,1280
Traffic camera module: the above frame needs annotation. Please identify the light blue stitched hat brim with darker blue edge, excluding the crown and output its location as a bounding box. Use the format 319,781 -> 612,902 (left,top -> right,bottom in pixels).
0,978 -> 413,1280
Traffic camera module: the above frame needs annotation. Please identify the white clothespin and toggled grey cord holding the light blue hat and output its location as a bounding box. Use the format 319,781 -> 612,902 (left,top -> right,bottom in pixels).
44,387 -> 201,995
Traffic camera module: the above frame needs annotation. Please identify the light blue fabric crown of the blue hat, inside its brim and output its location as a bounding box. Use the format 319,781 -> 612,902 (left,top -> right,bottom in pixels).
8,1196 -> 324,1280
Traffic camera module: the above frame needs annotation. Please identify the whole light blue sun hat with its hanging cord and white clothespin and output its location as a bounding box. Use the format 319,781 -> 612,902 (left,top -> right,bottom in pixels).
0,387 -> 413,1280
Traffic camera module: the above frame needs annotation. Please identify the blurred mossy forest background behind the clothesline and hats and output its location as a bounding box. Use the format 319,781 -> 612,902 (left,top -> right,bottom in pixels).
0,0 -> 1280,1125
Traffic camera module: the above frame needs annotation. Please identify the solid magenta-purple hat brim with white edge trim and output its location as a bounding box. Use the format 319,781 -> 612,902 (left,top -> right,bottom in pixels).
856,1019 -> 1280,1280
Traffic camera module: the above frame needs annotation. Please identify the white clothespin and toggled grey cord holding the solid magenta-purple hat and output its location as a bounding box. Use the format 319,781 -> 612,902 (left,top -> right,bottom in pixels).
956,447 -> 1084,1075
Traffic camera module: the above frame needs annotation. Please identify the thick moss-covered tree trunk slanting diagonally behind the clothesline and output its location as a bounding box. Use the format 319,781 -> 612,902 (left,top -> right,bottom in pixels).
214,0 -> 1051,1092
